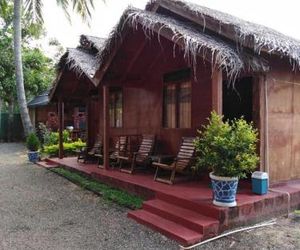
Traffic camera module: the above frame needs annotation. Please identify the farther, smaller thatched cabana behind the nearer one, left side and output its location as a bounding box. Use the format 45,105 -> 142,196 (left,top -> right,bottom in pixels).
49,35 -> 104,145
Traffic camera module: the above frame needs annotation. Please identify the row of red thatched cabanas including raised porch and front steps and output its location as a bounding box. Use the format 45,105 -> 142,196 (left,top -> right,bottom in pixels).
46,0 -> 300,245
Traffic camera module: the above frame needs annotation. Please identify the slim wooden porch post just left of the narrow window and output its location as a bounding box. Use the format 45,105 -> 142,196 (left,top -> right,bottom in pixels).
103,85 -> 109,169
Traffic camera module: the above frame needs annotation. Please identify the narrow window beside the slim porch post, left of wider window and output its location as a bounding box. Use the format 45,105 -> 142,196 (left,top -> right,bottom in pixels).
109,88 -> 123,128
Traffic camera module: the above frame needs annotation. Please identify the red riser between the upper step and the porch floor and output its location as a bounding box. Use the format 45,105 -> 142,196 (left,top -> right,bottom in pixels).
156,192 -> 224,220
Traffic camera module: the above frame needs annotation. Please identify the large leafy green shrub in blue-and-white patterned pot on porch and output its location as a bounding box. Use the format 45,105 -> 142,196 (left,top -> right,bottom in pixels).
195,112 -> 259,207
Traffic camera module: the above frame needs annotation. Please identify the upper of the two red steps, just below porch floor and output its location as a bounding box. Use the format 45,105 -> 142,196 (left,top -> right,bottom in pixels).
143,199 -> 219,238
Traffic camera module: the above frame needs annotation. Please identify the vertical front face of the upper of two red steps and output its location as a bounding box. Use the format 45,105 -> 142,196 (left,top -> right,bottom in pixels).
143,203 -> 219,236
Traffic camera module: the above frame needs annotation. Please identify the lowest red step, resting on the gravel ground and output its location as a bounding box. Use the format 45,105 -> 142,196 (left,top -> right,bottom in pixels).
128,209 -> 203,246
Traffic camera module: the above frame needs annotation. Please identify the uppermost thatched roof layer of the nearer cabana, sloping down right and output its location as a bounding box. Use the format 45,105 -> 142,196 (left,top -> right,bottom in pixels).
146,0 -> 300,67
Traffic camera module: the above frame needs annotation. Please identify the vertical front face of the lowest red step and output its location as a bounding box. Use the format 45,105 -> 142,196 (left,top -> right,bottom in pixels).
128,213 -> 202,246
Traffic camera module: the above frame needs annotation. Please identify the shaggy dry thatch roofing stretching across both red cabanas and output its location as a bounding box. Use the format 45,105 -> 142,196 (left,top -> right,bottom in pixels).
60,0 -> 300,84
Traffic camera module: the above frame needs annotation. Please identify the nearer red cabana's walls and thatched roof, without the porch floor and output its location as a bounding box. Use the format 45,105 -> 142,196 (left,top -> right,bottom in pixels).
89,0 -> 300,183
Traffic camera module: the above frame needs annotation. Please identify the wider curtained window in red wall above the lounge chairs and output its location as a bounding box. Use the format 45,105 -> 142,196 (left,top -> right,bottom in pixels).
163,81 -> 191,128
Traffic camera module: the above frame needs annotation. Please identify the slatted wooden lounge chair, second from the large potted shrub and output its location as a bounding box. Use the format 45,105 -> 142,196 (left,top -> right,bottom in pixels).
117,135 -> 155,174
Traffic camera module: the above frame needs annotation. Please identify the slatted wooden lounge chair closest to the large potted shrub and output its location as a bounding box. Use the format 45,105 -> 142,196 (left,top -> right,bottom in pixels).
152,137 -> 195,184
